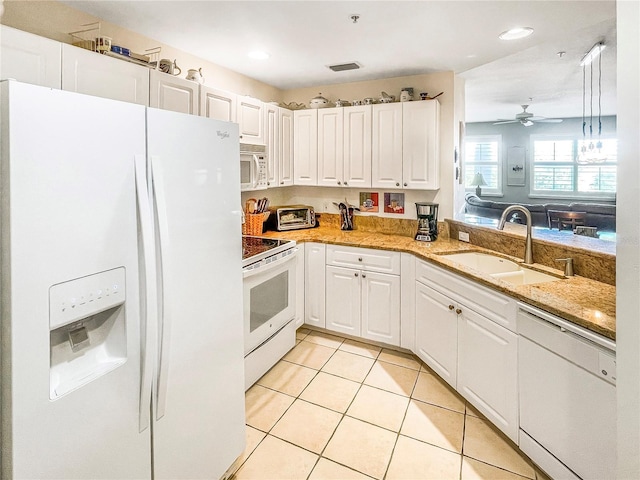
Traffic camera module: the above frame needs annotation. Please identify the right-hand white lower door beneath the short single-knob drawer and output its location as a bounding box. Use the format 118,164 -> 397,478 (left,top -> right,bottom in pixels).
362,271 -> 400,346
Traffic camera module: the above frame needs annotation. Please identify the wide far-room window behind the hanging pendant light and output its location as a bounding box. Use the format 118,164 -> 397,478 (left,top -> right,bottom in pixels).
531,136 -> 617,198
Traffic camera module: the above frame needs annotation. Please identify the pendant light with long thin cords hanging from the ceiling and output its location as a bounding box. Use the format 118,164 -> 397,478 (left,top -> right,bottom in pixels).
576,42 -> 607,165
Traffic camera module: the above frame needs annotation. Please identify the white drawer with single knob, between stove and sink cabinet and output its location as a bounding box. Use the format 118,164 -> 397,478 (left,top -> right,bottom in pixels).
327,245 -> 400,275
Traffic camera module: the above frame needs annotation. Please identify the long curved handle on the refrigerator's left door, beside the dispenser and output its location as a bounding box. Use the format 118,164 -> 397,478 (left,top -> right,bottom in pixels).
134,155 -> 158,432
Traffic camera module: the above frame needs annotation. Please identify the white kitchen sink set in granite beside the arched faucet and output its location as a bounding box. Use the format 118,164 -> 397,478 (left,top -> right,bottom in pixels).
442,252 -> 563,285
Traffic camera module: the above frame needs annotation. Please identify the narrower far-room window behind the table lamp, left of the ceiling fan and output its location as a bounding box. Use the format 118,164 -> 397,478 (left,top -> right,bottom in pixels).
464,135 -> 502,195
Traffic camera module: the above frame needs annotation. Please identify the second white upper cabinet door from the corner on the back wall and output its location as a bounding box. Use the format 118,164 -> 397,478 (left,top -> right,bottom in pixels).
318,108 -> 344,187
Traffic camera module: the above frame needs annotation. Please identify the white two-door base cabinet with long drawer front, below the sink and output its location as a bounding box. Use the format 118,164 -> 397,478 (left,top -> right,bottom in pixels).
415,260 -> 519,443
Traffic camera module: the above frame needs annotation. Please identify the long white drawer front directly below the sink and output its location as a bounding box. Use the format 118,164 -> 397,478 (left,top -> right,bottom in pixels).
416,259 -> 517,332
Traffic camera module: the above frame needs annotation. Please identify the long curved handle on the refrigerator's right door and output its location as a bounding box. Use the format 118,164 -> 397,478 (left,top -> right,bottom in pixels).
151,155 -> 171,420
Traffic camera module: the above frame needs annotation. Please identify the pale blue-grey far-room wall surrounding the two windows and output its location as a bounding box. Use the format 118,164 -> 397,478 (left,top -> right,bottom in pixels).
466,117 -> 616,203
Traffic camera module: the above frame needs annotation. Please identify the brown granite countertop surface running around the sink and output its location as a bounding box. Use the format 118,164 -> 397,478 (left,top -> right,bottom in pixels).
264,226 -> 616,340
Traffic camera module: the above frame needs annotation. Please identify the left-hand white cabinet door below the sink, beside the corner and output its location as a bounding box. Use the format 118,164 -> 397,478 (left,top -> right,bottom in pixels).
415,282 -> 458,388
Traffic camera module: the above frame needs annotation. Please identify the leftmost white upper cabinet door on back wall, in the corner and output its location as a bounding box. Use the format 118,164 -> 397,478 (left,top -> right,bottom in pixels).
293,109 -> 318,185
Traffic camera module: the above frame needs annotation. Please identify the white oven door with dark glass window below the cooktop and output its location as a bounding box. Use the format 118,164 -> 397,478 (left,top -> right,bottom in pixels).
243,249 -> 297,355
